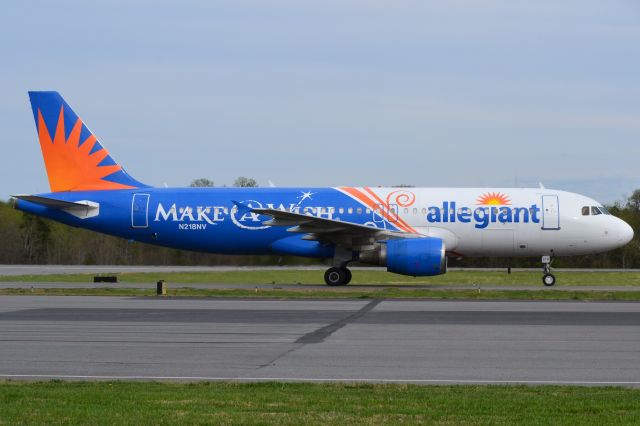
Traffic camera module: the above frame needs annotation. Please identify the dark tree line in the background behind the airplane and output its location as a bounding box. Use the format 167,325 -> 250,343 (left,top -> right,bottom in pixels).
0,178 -> 640,268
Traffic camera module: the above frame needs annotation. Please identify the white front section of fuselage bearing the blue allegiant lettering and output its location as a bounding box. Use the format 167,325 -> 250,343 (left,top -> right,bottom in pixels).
360,188 -> 633,256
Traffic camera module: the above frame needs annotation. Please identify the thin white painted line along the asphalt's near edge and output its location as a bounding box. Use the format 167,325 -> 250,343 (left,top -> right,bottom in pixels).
0,374 -> 640,385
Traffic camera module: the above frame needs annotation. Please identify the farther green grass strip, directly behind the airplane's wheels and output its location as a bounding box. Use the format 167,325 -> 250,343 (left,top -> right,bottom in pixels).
0,269 -> 640,288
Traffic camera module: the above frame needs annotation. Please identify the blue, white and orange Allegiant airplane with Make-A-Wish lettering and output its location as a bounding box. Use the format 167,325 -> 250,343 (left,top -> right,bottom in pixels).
13,91 -> 633,286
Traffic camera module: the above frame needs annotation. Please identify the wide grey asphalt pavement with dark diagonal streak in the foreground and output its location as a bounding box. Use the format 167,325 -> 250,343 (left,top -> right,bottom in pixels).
0,296 -> 640,386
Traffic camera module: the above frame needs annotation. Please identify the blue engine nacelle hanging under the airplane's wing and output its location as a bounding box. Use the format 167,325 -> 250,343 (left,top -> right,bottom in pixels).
359,237 -> 447,277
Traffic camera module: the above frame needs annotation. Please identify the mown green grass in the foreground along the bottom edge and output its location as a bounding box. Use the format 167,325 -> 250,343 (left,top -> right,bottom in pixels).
0,381 -> 640,425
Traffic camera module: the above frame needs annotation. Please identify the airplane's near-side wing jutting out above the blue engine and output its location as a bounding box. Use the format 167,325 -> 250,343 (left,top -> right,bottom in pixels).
250,208 -> 424,248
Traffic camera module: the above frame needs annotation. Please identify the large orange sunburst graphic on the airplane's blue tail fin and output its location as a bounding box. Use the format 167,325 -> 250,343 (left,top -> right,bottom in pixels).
38,106 -> 133,192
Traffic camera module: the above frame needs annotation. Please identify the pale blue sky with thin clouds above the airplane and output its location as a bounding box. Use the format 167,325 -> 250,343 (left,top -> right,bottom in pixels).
0,0 -> 640,203
